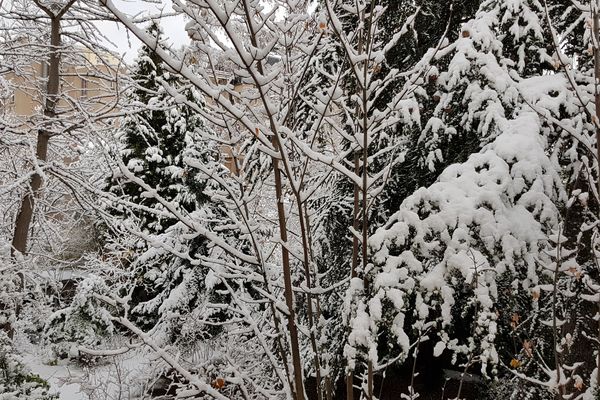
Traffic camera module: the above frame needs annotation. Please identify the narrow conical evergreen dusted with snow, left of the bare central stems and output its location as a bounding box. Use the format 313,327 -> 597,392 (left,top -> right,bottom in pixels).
104,23 -> 235,341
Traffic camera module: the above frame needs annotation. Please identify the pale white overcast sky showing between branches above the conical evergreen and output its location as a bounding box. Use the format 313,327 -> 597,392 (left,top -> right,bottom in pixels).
99,0 -> 189,62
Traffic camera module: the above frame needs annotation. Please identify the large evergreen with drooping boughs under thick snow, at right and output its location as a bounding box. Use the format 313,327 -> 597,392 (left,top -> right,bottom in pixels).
348,0 -> 594,398
